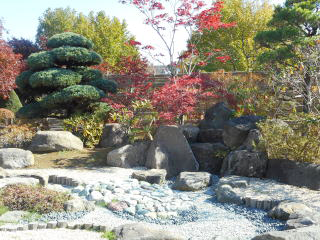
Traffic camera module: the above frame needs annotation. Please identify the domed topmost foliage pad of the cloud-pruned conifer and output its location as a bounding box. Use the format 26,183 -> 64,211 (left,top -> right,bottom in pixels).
47,32 -> 93,49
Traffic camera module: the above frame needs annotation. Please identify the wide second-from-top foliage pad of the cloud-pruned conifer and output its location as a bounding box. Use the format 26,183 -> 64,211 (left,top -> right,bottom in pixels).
51,47 -> 102,66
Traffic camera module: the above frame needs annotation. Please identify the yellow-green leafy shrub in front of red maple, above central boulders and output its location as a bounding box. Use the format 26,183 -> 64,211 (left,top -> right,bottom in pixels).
110,100 -> 158,142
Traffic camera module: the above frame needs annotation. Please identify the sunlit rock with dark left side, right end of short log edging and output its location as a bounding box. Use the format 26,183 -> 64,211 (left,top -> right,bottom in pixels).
268,201 -> 312,220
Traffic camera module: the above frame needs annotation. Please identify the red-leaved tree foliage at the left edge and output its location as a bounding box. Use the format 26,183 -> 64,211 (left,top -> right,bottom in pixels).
0,40 -> 24,99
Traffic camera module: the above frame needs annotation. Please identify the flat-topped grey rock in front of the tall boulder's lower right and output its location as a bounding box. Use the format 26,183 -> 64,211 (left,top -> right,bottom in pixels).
172,172 -> 211,191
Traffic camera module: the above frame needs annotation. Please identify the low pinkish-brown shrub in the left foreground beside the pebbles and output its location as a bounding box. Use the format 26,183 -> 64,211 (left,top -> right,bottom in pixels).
0,184 -> 70,214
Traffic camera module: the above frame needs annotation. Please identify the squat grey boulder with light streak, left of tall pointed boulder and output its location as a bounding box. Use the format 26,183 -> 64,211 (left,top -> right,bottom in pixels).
107,142 -> 149,168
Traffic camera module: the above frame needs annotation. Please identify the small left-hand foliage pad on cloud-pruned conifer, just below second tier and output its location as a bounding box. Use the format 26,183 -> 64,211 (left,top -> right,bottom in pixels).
27,51 -> 55,71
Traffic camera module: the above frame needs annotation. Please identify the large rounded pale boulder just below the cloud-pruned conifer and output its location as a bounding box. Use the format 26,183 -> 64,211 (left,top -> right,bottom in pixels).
30,131 -> 83,152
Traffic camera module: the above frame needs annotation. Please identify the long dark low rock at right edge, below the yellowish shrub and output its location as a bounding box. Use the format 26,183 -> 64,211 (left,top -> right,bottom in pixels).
266,159 -> 320,190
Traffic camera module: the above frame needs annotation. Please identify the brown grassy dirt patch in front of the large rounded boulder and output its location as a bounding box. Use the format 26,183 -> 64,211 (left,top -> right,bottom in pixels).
31,148 -> 111,168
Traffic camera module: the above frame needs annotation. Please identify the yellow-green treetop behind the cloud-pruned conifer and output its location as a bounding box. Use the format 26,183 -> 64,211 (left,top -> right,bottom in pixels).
36,7 -> 138,66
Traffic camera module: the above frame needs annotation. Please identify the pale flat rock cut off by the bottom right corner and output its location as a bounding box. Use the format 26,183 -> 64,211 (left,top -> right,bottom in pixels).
252,226 -> 320,240
